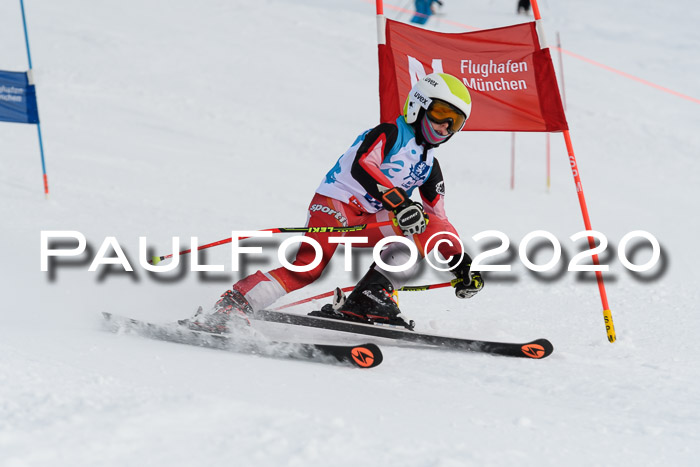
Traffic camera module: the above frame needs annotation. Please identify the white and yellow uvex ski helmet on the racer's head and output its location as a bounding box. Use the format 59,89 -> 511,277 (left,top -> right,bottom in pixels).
403,73 -> 472,131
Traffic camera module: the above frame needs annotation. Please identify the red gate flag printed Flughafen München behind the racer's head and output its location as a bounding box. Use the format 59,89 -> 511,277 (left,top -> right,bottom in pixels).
379,19 -> 568,131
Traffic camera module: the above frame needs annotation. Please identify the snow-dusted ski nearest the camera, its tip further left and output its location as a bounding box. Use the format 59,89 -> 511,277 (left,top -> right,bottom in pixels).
102,312 -> 383,368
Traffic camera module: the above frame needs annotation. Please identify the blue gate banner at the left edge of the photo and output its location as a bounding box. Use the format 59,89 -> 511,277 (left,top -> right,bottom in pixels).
0,71 -> 39,123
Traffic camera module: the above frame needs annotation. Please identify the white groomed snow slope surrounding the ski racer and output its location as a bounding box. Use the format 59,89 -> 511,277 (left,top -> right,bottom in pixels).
0,0 -> 700,467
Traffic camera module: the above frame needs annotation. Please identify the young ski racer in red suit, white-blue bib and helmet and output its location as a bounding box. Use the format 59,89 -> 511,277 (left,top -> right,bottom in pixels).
185,73 -> 484,332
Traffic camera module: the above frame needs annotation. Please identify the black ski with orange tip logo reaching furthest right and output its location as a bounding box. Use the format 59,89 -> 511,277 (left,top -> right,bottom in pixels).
251,310 -> 554,359
